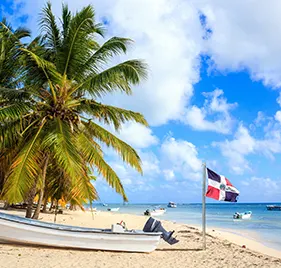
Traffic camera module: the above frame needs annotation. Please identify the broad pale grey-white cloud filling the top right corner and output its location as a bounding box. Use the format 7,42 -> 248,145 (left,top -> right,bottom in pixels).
194,0 -> 281,87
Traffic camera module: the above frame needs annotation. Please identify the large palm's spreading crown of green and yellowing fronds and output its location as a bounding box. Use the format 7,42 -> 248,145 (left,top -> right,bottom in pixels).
0,3 -> 147,218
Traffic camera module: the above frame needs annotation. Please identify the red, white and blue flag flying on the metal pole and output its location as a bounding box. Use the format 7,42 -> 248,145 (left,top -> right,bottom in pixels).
206,168 -> 239,202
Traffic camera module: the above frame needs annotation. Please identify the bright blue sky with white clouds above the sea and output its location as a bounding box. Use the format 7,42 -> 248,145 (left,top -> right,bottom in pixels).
0,0 -> 281,203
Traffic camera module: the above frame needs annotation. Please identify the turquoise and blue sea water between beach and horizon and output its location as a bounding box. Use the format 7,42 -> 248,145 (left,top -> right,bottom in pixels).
93,203 -> 281,250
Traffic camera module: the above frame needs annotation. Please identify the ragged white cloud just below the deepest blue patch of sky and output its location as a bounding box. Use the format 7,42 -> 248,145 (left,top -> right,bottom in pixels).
183,89 -> 237,134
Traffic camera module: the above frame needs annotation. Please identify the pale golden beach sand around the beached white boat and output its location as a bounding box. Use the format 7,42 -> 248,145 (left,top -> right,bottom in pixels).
0,211 -> 281,268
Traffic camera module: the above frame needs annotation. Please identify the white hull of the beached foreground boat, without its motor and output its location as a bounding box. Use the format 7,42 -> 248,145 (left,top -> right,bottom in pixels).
0,214 -> 161,252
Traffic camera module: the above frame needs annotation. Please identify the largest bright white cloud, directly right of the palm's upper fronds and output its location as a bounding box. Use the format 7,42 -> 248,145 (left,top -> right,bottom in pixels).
98,0 -> 202,125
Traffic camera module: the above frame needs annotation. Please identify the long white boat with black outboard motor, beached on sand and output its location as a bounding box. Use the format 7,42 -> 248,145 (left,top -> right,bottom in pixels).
0,213 -> 162,252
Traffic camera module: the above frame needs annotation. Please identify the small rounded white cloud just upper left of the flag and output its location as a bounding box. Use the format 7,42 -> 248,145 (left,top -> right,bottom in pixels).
160,137 -> 202,180
